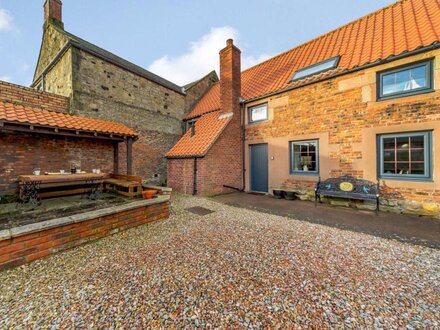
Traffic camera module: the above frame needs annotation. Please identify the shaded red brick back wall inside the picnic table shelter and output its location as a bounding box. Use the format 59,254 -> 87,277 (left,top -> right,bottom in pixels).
0,132 -> 113,194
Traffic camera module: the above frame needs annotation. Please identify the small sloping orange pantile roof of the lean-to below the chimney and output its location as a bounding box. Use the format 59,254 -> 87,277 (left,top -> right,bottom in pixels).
166,111 -> 232,158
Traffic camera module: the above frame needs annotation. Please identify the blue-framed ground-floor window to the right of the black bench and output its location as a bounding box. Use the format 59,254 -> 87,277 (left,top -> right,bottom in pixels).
378,131 -> 432,181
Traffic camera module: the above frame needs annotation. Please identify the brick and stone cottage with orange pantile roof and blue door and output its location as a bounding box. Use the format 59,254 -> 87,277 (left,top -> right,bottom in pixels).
167,0 -> 440,214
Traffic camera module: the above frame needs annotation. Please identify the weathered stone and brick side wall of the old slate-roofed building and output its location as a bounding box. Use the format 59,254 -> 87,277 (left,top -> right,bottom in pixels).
72,50 -> 185,181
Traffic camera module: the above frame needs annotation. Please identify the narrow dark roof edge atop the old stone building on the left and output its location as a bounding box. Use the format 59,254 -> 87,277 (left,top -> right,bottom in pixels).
54,25 -> 184,94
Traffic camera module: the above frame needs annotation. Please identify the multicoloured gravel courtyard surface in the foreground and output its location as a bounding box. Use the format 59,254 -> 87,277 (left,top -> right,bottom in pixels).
0,196 -> 440,329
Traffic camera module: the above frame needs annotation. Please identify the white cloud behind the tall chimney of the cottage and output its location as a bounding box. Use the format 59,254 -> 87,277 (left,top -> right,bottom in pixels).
148,26 -> 269,85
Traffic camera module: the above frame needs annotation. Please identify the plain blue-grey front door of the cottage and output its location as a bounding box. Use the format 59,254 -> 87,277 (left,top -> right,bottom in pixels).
249,144 -> 269,192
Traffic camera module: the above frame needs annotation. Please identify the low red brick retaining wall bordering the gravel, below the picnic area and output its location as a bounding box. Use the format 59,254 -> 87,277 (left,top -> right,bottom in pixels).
0,202 -> 169,270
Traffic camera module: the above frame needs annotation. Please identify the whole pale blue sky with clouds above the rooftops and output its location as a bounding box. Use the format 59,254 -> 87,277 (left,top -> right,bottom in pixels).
0,0 -> 395,85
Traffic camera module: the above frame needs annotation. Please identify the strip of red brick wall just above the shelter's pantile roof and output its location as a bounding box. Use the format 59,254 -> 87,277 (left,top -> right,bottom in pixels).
0,81 -> 69,113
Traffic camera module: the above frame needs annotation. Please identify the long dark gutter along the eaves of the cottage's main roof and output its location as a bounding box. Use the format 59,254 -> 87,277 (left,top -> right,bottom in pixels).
244,42 -> 440,104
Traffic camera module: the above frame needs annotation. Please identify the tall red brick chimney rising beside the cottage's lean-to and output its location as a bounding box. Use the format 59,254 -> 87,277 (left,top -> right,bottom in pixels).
220,39 -> 241,118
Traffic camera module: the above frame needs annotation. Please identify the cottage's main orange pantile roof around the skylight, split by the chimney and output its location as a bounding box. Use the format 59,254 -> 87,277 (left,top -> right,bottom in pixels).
187,0 -> 440,118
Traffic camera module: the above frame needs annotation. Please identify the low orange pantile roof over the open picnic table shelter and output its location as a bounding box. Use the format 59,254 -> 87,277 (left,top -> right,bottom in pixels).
0,101 -> 137,136
